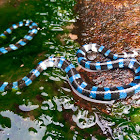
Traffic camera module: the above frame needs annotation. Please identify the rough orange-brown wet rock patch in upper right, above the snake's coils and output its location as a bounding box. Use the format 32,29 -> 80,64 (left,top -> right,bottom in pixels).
76,0 -> 140,49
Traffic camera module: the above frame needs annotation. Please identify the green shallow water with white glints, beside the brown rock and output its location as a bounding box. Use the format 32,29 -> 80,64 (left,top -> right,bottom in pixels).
0,0 -> 140,140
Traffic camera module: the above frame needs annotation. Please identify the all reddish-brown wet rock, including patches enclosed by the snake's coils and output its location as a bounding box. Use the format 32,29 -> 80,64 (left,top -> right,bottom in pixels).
73,0 -> 140,96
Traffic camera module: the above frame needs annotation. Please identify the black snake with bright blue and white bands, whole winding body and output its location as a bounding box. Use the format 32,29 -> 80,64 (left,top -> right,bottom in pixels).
0,20 -> 140,101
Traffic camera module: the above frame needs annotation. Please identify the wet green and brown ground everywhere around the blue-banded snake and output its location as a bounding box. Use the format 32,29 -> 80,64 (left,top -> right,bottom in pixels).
0,0 -> 140,140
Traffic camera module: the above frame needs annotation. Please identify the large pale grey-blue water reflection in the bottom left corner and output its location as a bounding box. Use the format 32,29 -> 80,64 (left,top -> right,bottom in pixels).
0,111 -> 46,140
